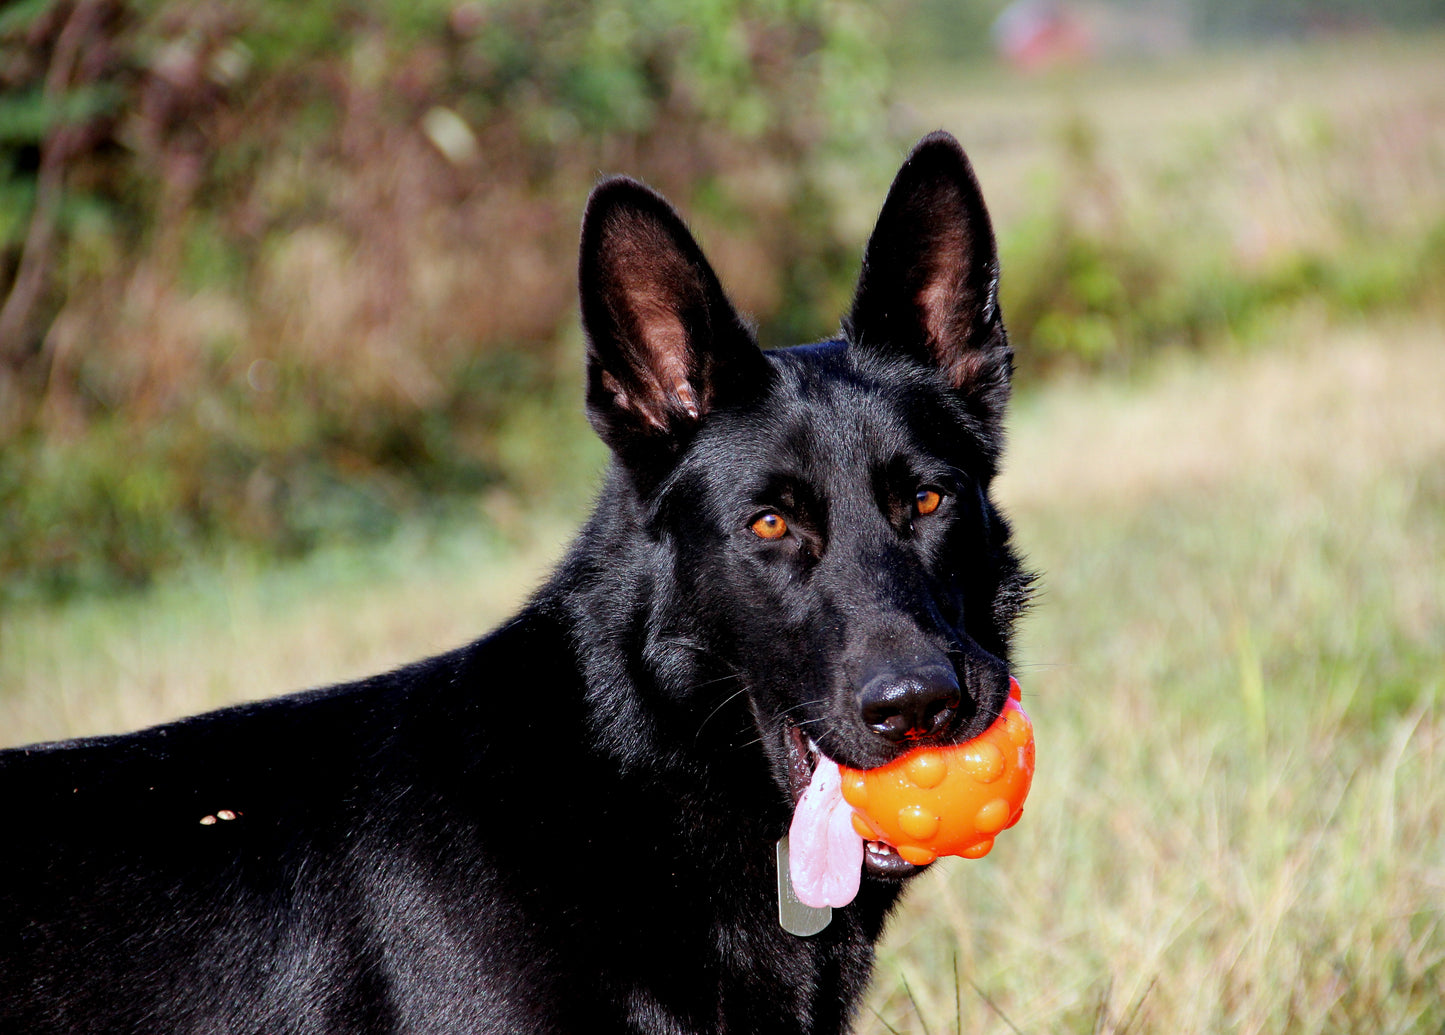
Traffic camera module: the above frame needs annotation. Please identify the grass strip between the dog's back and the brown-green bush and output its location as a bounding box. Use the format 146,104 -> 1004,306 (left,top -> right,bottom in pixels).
0,522 -> 566,744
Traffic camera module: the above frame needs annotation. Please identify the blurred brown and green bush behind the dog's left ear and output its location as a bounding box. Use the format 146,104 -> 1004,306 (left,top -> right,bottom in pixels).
0,0 -> 887,603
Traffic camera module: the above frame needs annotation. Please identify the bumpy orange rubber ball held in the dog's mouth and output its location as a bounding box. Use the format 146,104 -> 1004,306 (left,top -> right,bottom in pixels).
842,677 -> 1033,866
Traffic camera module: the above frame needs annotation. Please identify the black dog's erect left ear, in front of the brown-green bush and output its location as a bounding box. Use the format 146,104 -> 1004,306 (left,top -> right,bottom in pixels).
578,176 -> 767,452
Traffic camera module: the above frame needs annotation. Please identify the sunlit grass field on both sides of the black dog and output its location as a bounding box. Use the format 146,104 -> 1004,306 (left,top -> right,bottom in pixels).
0,315 -> 1445,1035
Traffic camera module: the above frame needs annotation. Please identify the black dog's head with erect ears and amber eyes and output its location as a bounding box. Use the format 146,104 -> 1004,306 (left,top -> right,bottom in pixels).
581,133 -> 1029,875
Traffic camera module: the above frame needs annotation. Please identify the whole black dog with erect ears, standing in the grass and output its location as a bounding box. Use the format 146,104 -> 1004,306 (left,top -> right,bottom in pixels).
0,133 -> 1029,1035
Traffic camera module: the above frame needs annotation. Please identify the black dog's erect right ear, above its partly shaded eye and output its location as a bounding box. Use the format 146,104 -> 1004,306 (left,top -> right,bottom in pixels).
844,130 -> 1013,421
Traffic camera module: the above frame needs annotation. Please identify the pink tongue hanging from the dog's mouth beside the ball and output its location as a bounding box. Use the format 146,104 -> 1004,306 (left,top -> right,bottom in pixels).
788,756 -> 863,908
